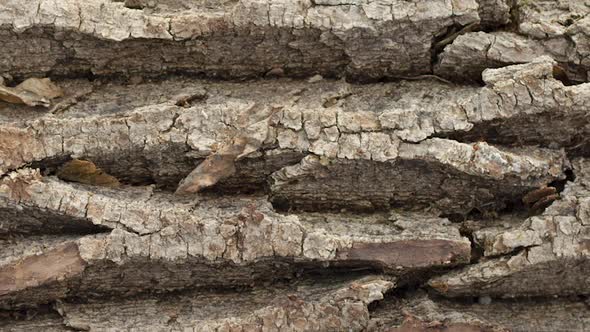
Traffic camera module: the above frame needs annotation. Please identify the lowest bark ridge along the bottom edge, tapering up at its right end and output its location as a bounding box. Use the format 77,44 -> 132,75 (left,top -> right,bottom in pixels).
1,276 -> 394,331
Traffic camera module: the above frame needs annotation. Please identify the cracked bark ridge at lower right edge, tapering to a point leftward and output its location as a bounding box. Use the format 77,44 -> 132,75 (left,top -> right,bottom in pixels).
429,159 -> 590,297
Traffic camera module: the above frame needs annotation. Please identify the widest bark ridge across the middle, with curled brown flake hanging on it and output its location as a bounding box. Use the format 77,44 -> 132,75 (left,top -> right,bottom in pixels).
0,58 -> 587,214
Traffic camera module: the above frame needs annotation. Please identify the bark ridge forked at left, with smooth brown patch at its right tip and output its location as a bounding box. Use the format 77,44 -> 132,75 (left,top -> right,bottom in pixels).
0,170 -> 471,305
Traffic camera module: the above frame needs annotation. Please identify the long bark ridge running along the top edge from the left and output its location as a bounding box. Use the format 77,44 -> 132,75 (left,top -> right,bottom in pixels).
0,0 -> 479,78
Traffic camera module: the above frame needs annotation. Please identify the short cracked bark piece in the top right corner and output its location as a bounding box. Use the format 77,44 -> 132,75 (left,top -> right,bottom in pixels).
434,0 -> 590,82
